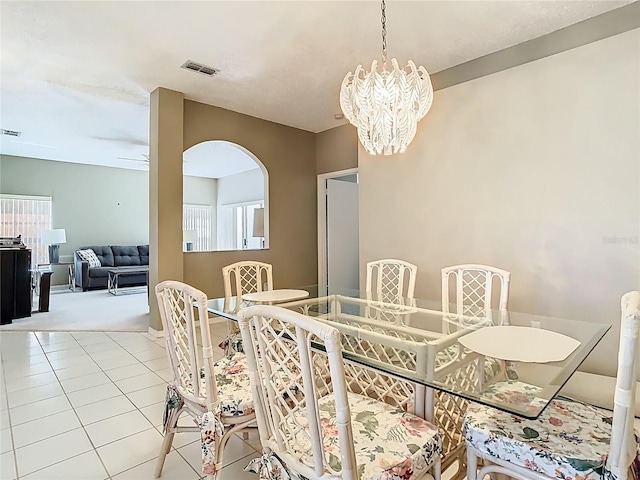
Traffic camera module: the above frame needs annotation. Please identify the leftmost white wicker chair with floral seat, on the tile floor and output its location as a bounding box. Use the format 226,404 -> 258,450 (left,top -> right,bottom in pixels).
155,281 -> 256,480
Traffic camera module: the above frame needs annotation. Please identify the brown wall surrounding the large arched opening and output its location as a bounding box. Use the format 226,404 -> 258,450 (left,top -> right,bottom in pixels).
183,100 -> 317,297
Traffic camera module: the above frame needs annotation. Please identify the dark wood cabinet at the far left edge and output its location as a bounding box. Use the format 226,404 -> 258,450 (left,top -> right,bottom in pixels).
0,248 -> 31,324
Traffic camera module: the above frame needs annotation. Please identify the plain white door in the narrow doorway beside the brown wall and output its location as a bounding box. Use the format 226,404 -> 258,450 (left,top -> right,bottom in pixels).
326,174 -> 360,293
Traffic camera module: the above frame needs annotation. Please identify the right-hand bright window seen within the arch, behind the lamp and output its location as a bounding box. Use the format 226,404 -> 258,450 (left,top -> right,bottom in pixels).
218,203 -> 264,250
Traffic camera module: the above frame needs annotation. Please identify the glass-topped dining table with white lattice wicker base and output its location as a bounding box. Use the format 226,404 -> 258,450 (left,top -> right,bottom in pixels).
208,286 -> 611,475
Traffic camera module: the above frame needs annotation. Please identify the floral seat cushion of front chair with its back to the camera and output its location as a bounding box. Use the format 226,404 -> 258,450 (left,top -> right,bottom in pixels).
290,393 -> 442,480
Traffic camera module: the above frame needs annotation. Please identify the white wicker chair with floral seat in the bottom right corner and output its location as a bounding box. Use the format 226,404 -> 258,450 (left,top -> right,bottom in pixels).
465,292 -> 640,480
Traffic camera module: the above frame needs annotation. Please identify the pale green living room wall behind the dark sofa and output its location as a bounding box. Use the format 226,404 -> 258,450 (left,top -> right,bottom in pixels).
0,155 -> 149,285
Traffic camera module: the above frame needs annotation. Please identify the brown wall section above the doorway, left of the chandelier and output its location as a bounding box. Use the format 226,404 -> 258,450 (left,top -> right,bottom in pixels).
316,124 -> 358,174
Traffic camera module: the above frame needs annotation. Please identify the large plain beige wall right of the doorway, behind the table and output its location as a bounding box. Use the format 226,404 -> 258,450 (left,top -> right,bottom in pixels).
358,29 -> 640,375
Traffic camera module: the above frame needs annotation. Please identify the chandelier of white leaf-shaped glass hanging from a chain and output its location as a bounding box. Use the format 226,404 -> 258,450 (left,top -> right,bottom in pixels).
340,0 -> 433,155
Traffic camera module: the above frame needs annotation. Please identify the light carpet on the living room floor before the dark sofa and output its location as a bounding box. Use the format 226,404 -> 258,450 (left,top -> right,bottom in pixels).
0,289 -> 149,332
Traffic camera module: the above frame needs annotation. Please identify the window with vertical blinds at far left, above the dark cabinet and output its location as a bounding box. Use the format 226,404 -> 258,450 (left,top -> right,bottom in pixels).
0,195 -> 51,265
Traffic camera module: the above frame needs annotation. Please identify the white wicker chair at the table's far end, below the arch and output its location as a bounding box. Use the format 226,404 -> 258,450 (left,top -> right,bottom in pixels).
220,260 -> 273,355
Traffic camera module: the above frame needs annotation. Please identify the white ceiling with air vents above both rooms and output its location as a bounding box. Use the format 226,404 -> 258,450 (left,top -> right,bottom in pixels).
0,0 -> 631,177
